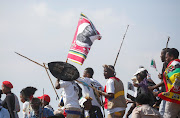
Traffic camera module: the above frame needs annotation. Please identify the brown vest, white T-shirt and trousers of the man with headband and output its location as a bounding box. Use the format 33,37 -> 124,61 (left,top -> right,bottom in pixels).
104,77 -> 127,118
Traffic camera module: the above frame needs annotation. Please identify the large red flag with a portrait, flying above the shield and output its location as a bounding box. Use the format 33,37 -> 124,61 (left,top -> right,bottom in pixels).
67,13 -> 101,65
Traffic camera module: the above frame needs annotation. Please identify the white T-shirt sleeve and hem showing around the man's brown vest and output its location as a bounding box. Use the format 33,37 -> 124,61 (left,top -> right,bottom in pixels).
106,79 -> 126,114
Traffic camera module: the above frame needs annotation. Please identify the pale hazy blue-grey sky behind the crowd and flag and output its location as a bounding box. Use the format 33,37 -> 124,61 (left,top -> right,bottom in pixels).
0,0 -> 180,115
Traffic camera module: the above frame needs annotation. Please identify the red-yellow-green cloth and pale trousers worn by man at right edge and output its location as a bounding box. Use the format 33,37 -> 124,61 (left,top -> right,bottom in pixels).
158,59 -> 180,118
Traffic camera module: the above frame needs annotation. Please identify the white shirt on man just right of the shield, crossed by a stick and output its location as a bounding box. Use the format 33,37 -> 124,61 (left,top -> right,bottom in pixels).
78,77 -> 103,107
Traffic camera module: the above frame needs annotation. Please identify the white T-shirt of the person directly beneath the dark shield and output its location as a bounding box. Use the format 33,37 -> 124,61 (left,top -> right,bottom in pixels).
60,81 -> 80,108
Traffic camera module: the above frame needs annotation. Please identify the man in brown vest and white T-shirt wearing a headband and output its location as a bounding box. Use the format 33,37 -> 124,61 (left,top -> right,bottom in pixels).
95,65 -> 127,118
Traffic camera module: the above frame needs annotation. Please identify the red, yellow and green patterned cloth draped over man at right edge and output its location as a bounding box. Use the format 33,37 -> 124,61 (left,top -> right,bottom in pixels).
158,59 -> 180,104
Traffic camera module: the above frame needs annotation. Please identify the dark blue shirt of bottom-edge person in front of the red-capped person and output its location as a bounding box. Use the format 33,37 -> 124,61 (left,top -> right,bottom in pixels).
30,107 -> 54,118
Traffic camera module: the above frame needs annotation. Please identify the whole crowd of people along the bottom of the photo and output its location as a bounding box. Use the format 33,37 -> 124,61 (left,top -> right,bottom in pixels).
0,48 -> 180,118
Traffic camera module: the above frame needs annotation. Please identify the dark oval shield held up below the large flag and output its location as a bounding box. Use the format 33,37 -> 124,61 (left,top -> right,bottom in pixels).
48,61 -> 79,81
